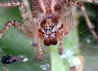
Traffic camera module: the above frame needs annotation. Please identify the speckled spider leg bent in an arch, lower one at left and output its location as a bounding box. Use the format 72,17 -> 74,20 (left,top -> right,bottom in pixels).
0,21 -> 32,38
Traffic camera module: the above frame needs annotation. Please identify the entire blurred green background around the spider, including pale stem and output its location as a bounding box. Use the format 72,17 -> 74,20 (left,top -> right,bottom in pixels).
0,0 -> 98,71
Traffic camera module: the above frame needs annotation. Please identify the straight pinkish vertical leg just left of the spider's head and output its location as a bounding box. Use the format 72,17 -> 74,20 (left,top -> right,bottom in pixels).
32,0 -> 39,45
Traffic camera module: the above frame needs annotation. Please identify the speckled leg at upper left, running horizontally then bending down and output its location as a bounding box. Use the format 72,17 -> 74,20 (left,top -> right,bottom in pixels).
0,1 -> 32,30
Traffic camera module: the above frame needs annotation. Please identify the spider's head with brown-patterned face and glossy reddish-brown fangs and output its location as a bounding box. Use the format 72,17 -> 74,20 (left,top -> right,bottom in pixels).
40,19 -> 58,46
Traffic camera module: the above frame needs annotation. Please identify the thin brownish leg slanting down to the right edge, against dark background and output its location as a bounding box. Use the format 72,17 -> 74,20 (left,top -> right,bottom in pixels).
76,2 -> 98,41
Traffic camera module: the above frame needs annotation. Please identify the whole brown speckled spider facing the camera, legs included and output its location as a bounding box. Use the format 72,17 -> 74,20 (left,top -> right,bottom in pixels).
0,0 -> 98,60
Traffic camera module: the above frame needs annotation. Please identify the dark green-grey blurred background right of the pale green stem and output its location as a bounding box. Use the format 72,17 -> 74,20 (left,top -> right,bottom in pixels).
78,3 -> 98,71
